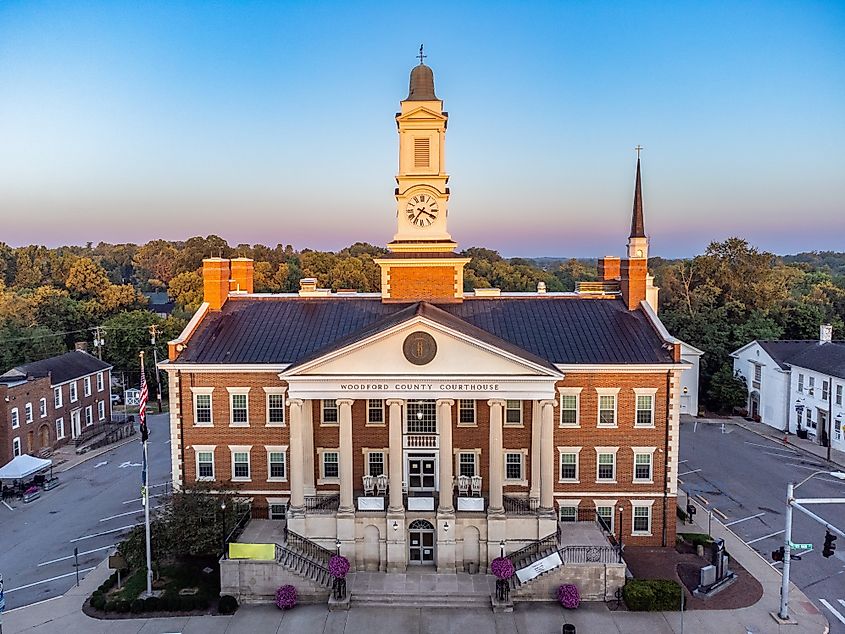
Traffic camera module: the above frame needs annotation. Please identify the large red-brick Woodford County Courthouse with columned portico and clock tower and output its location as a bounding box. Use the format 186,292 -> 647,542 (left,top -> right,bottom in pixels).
161,59 -> 687,588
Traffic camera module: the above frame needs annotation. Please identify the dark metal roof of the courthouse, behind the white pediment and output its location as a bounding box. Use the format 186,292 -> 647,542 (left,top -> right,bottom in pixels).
178,297 -> 672,364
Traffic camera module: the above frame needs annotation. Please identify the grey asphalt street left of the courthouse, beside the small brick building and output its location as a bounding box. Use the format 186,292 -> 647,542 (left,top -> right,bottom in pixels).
0,414 -> 170,610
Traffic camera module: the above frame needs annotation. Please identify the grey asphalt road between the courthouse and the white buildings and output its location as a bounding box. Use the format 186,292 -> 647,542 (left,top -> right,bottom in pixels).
678,422 -> 845,634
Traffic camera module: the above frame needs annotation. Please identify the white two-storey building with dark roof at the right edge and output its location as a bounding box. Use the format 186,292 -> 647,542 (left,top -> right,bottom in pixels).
731,325 -> 845,442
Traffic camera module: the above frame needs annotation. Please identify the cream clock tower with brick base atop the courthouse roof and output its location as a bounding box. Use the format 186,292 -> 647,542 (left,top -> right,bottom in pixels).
376,47 -> 469,302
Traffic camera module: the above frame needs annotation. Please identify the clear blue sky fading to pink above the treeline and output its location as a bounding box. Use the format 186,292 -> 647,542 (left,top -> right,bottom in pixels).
0,0 -> 845,257
